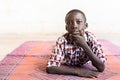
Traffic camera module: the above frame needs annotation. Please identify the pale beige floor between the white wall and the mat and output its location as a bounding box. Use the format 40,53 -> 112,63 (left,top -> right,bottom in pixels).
0,32 -> 120,61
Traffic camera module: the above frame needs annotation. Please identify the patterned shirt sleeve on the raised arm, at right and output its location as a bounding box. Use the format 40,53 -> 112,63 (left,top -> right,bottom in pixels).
88,33 -> 106,63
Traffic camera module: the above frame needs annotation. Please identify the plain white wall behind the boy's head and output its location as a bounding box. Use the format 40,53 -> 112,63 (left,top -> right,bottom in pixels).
0,0 -> 120,33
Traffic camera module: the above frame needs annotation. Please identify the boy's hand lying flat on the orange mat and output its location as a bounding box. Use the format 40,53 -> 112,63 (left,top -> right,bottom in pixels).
75,69 -> 99,78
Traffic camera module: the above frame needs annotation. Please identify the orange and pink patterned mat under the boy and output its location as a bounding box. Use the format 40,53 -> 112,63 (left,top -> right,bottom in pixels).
0,40 -> 120,80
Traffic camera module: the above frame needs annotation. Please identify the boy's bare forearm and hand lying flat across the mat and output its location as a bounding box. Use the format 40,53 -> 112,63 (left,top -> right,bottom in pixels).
46,66 -> 98,78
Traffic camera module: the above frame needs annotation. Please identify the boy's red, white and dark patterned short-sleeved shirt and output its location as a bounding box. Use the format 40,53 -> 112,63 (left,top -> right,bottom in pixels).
47,31 -> 106,67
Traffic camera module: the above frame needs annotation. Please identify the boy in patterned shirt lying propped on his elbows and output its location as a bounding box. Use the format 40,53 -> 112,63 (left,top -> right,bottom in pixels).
46,9 -> 106,78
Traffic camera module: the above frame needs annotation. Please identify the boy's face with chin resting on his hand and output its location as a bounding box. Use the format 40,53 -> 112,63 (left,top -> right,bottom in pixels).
66,13 -> 86,36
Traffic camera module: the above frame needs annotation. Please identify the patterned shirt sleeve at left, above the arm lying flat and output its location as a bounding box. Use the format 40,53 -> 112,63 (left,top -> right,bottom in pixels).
47,37 -> 65,67
